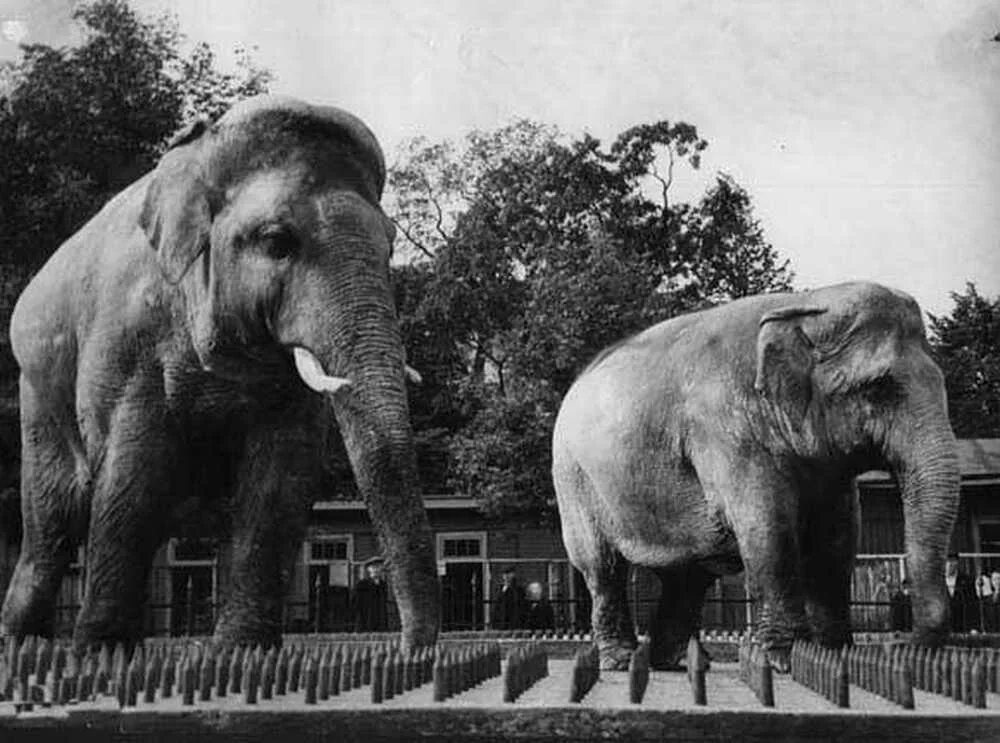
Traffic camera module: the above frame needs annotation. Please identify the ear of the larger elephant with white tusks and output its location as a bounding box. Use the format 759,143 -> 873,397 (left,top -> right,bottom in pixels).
139,120 -> 212,284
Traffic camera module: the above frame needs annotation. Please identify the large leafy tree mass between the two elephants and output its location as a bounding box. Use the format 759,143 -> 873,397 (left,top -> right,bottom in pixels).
390,121 -> 791,519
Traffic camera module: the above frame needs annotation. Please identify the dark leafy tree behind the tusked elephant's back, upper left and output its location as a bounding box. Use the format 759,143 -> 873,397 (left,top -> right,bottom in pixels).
0,0 -> 270,269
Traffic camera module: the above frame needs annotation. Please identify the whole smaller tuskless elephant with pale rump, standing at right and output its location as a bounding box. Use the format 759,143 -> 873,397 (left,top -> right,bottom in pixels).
552,283 -> 959,670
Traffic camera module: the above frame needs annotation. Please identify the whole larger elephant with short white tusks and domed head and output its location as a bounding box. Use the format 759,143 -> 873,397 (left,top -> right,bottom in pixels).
0,97 -> 440,646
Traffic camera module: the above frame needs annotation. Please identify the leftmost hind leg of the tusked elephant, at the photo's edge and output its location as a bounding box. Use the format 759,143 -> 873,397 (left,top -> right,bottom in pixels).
0,378 -> 86,637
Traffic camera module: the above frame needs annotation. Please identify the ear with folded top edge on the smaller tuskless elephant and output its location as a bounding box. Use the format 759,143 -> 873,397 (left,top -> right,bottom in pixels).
754,306 -> 826,420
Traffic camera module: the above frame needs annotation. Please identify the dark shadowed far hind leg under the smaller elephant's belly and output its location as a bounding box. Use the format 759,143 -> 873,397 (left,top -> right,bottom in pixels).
650,565 -> 715,670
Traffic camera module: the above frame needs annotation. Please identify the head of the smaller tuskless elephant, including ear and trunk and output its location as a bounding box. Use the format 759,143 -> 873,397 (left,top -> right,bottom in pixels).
755,284 -> 959,643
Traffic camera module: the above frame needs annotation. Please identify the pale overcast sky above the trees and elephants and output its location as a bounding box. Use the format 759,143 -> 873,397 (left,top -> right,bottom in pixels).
0,0 -> 1000,313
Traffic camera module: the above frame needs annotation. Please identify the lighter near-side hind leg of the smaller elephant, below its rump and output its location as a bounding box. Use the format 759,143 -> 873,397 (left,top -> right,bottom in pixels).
555,465 -> 637,670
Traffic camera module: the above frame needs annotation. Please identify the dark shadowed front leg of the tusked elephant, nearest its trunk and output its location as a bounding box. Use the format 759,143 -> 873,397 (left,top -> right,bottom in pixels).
214,426 -> 321,647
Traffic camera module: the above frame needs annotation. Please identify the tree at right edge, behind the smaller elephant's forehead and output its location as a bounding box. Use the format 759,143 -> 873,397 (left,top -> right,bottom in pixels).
929,283 -> 1000,438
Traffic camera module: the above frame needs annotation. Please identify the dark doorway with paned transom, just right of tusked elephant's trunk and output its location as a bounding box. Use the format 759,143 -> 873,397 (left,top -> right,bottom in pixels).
437,532 -> 489,631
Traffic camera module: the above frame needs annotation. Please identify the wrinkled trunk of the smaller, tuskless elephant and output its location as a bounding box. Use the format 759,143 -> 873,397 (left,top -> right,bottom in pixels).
889,384 -> 960,645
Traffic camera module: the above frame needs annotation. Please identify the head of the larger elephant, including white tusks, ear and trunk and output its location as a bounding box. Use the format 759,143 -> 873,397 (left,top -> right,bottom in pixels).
140,97 -> 439,644
